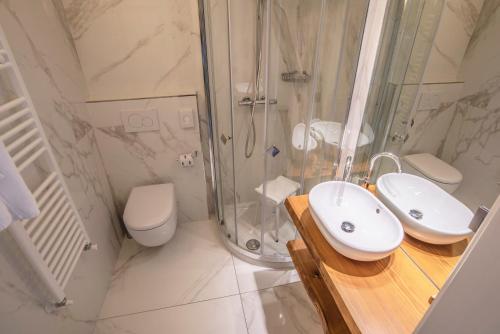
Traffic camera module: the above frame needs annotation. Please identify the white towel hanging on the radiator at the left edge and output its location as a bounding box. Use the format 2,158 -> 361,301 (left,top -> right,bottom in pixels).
0,142 -> 40,231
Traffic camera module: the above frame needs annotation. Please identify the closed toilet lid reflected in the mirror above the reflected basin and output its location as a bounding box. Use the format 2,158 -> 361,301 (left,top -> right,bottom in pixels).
404,153 -> 462,184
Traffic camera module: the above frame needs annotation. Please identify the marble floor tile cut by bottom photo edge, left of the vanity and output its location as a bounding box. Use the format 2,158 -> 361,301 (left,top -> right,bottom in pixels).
94,296 -> 247,334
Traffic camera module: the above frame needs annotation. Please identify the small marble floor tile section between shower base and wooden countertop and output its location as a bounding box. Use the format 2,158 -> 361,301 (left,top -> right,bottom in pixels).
233,256 -> 300,293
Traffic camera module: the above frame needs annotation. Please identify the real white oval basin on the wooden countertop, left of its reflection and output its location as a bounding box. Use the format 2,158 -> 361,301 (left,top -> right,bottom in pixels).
309,181 -> 404,261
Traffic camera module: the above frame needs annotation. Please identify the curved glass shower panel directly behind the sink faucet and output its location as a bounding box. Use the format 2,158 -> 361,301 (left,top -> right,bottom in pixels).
303,0 -> 369,188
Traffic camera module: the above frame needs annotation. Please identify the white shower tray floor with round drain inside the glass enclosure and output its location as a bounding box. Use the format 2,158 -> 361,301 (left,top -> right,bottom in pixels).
224,201 -> 296,256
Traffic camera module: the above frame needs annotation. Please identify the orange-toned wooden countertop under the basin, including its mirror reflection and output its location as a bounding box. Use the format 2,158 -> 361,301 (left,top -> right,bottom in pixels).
285,195 -> 465,333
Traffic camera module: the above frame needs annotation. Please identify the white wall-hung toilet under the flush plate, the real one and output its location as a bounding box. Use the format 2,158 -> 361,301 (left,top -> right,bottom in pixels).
123,183 -> 177,247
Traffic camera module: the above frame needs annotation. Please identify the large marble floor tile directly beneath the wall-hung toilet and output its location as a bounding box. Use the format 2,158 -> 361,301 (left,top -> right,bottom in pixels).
100,221 -> 239,319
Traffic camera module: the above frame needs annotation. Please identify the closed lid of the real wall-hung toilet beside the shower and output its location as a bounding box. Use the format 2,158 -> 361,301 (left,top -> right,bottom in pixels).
123,183 -> 175,231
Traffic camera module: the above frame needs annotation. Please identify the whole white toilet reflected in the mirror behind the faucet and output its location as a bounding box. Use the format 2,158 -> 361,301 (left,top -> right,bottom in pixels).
403,153 -> 463,194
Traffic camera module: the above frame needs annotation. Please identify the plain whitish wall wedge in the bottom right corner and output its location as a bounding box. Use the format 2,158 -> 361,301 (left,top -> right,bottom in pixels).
416,197 -> 500,334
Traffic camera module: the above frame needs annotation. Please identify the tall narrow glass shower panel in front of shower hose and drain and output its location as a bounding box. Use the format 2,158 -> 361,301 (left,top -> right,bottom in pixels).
228,0 -> 268,254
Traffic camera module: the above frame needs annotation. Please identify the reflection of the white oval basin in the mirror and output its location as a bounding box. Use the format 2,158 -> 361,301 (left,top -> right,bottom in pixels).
377,173 -> 473,245
